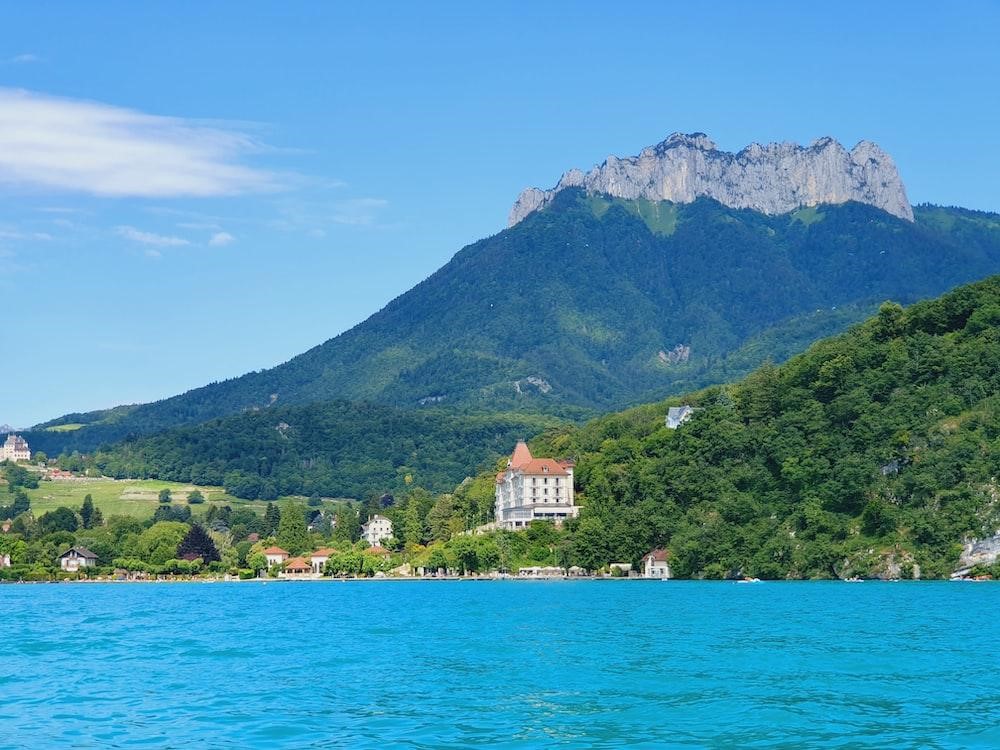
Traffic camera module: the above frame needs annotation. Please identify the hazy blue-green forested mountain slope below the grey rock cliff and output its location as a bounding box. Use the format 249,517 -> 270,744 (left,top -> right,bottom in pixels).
28,197 -> 1000,454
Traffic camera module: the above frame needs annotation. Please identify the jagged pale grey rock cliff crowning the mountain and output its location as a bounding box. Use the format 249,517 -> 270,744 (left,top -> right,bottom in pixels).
509,133 -> 913,226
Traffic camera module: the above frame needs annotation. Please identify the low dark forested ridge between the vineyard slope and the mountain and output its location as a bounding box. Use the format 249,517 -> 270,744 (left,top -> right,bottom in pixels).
59,401 -> 557,500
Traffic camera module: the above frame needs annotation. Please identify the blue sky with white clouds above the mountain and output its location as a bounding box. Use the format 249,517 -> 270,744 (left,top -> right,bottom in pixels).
0,2 -> 1000,427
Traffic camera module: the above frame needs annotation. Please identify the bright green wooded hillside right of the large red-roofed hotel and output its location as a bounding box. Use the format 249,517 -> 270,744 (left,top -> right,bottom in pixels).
533,277 -> 1000,578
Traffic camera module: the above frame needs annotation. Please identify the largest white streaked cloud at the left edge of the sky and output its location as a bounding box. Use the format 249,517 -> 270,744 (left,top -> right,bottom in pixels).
0,88 -> 280,198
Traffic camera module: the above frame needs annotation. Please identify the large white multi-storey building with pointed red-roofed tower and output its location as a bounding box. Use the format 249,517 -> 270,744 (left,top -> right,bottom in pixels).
494,440 -> 580,530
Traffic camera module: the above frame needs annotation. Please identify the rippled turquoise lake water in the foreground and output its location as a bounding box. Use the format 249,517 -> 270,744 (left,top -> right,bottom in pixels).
0,581 -> 1000,750
